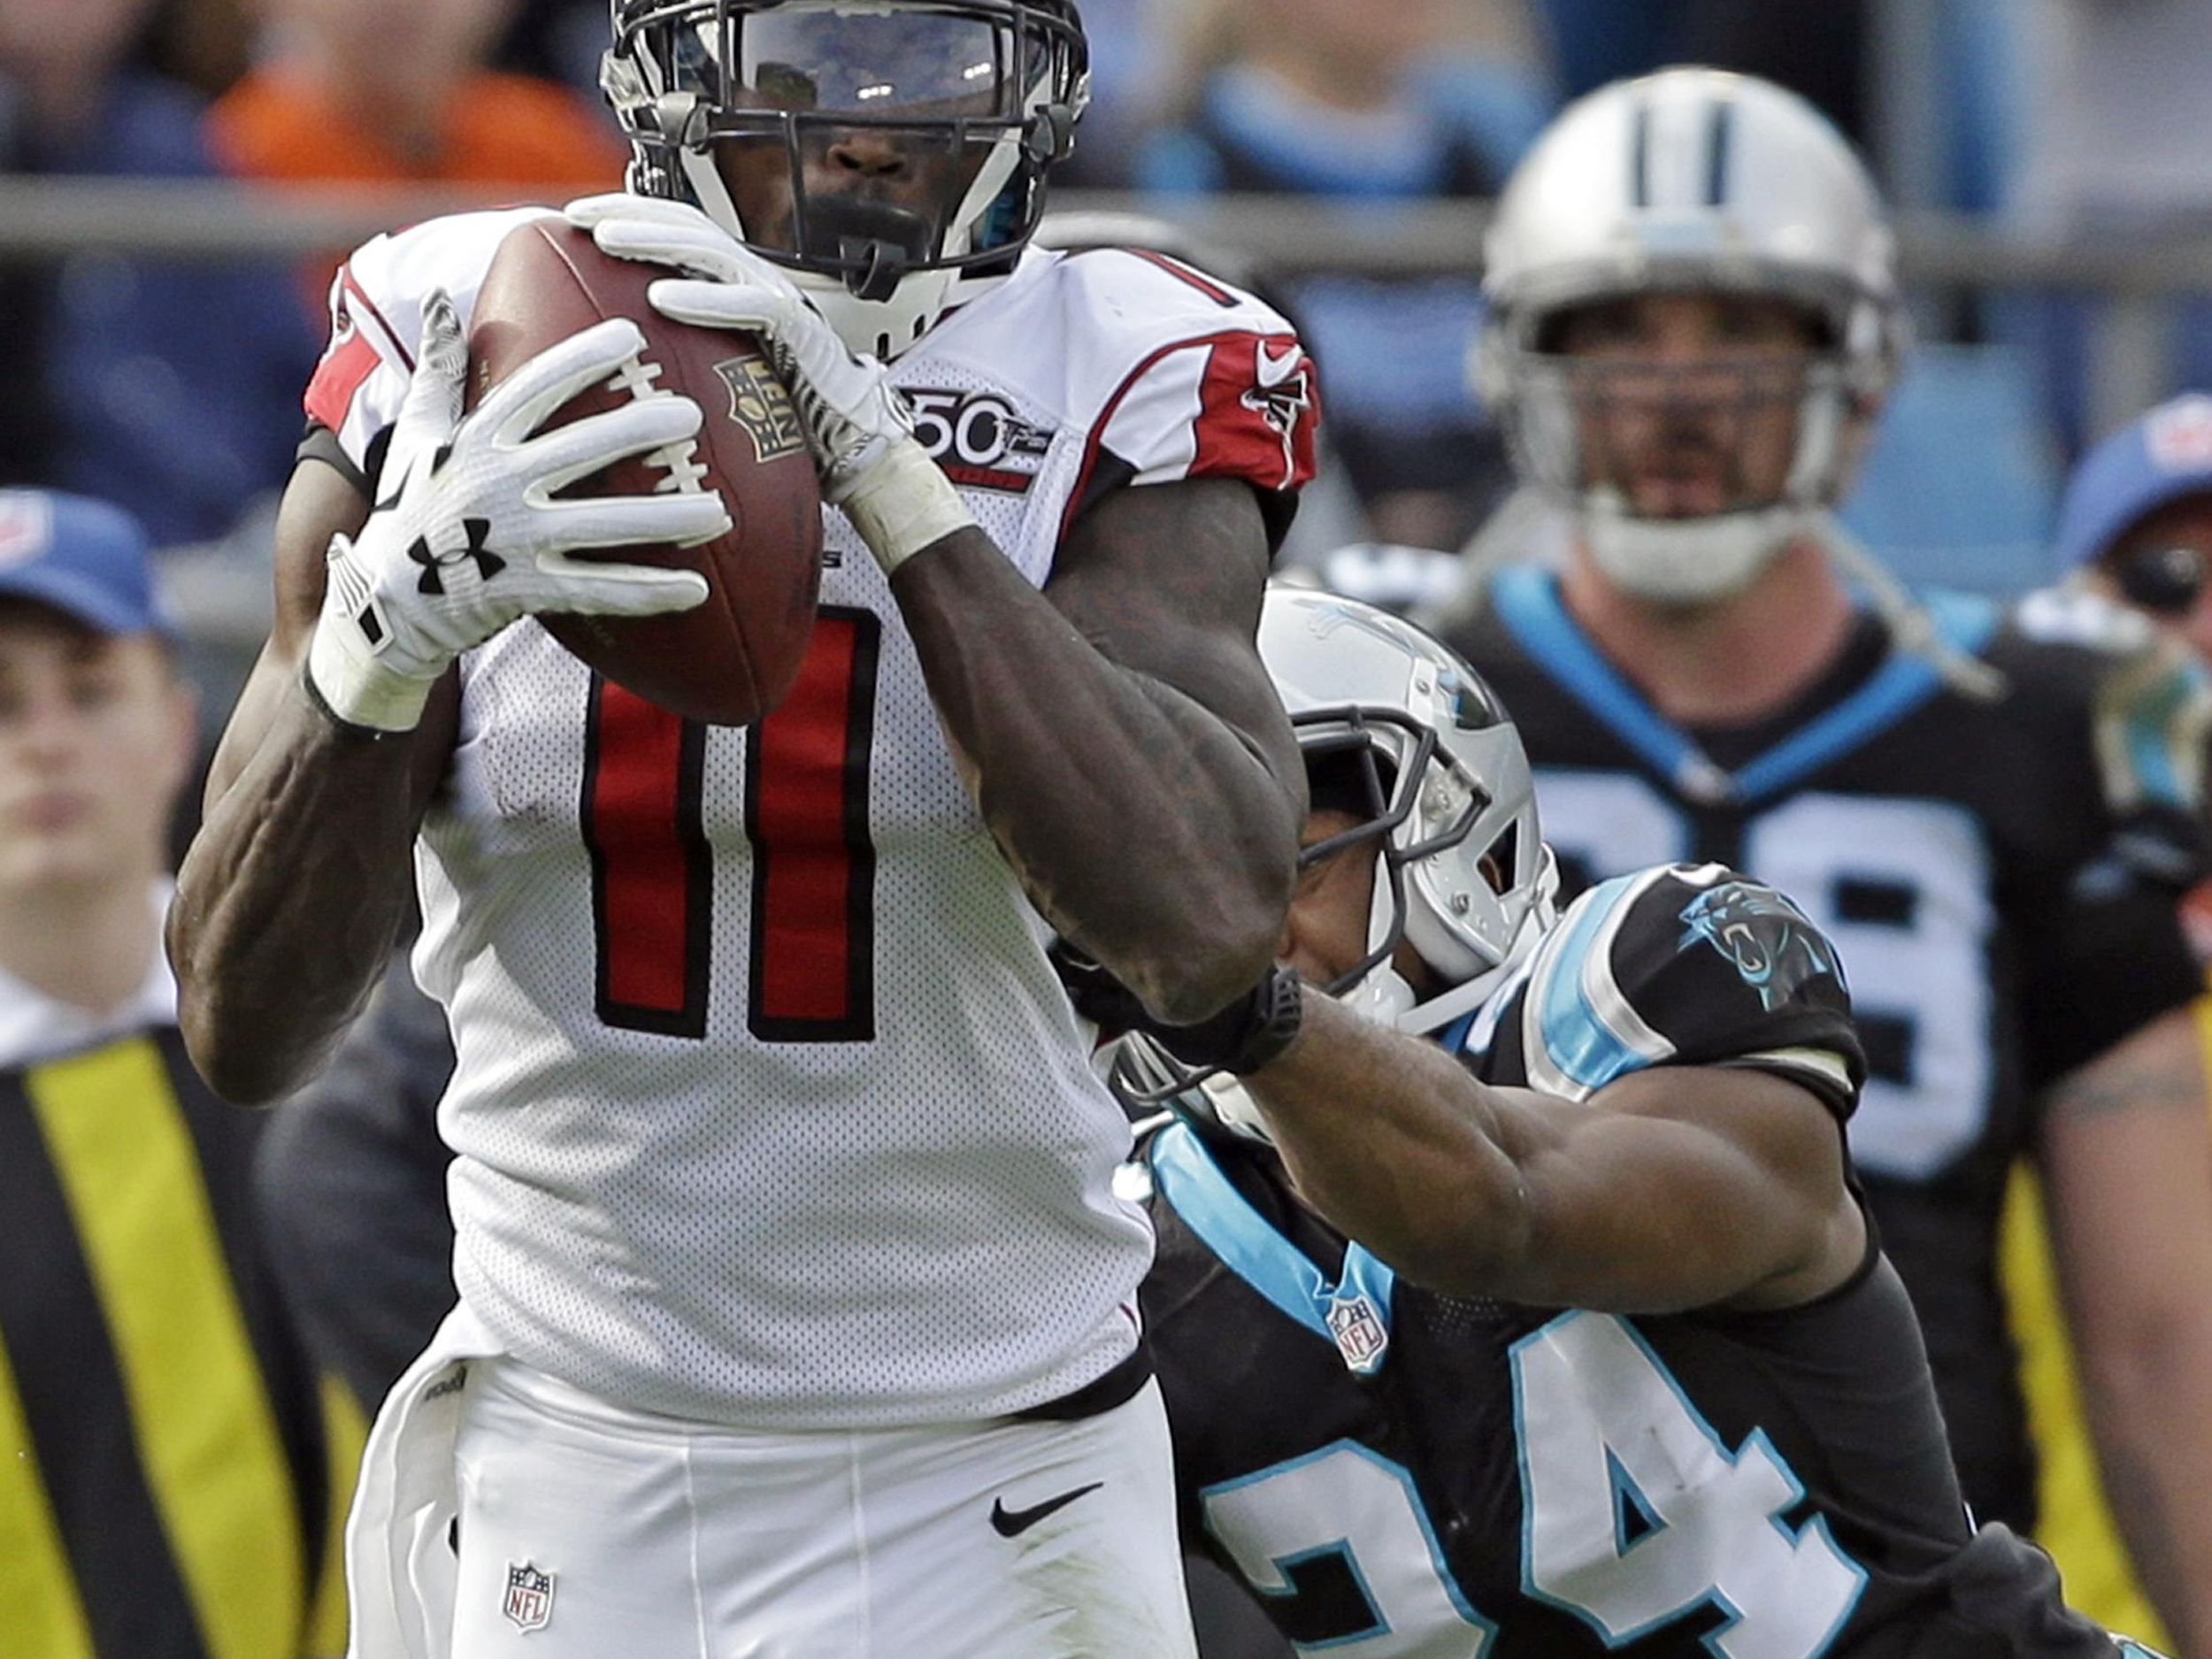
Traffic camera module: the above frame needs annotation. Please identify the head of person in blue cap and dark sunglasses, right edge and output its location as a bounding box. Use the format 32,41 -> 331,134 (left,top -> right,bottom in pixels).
2057,392 -> 2212,659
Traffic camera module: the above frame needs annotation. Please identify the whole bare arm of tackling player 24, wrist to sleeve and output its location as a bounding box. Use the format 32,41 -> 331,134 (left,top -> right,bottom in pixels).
1248,998 -> 1865,1314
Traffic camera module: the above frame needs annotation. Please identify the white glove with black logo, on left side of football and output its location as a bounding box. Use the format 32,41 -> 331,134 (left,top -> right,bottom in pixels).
308,292 -> 730,733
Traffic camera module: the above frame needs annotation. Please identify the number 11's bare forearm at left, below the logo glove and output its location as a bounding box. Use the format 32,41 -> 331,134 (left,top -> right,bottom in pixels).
171,686 -> 420,1104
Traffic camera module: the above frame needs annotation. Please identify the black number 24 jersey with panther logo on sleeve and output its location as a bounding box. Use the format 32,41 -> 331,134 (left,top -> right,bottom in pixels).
1144,867 -> 2117,1659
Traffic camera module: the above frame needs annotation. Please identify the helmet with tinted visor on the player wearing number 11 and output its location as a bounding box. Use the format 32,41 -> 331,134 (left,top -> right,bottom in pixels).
600,0 -> 1091,361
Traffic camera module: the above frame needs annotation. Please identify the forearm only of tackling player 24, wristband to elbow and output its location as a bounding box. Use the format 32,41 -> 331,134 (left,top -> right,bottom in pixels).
1246,994 -> 1531,1294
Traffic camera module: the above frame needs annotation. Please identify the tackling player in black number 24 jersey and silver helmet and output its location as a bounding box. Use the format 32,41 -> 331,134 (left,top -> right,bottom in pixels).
1075,591 -> 2144,1659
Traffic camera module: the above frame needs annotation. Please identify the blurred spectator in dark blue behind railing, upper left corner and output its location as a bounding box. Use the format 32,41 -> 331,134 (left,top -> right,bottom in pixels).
0,0 -> 319,544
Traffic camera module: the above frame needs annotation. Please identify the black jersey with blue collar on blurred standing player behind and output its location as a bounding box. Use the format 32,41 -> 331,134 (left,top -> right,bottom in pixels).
1447,569 -> 2206,1531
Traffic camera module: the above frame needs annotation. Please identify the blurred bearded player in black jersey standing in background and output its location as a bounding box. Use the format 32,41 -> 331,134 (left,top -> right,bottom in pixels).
1442,69 -> 2212,1655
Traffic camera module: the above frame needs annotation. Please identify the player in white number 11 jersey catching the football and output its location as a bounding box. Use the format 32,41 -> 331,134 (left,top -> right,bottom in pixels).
173,0 -> 1318,1659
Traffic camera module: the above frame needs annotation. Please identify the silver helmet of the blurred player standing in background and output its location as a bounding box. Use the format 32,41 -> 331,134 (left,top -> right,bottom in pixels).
1473,69 -> 1907,604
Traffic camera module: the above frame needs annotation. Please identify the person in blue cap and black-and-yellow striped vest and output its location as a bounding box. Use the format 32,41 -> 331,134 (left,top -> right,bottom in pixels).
0,491 -> 343,1659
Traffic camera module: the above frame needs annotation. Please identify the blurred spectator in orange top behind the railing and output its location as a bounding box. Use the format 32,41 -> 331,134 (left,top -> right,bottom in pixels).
212,0 -> 624,195
